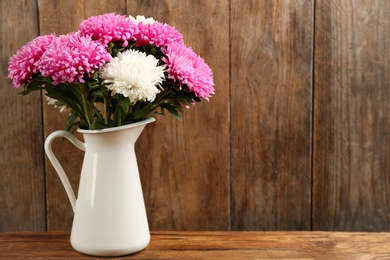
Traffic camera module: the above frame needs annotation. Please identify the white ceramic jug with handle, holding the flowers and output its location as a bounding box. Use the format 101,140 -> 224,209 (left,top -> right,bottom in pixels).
45,118 -> 155,256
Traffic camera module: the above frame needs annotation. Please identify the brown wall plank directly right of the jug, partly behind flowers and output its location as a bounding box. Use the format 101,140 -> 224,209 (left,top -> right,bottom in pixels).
127,0 -> 229,230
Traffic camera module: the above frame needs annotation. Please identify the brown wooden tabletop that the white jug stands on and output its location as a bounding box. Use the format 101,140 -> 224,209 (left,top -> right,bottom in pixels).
0,231 -> 390,260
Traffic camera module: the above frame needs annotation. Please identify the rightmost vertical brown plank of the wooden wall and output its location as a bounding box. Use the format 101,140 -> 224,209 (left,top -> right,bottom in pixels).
313,0 -> 390,231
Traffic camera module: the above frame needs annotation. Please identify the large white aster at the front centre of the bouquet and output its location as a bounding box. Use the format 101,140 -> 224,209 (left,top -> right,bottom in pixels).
100,50 -> 164,103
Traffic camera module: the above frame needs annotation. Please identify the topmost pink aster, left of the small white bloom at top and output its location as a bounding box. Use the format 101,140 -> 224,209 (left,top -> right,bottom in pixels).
79,13 -> 138,47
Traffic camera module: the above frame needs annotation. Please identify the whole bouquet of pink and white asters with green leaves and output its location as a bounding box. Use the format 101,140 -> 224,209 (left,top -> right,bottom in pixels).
8,13 -> 214,131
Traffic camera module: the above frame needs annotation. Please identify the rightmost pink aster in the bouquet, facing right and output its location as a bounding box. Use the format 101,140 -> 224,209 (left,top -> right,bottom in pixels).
162,43 -> 214,100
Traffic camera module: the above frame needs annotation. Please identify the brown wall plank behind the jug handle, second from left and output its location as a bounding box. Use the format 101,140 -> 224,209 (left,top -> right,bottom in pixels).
40,0 -> 125,230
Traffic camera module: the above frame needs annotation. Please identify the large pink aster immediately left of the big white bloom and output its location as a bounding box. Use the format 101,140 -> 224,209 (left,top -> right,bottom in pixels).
38,33 -> 111,85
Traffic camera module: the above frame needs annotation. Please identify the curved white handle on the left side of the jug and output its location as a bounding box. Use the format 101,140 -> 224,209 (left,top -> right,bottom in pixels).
45,130 -> 85,212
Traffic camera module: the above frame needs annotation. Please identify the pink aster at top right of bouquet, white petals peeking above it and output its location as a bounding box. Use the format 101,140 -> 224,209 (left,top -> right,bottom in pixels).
129,16 -> 183,47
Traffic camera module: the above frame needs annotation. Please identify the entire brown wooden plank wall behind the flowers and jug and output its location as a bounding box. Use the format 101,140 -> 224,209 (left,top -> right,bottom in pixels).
0,0 -> 390,231
